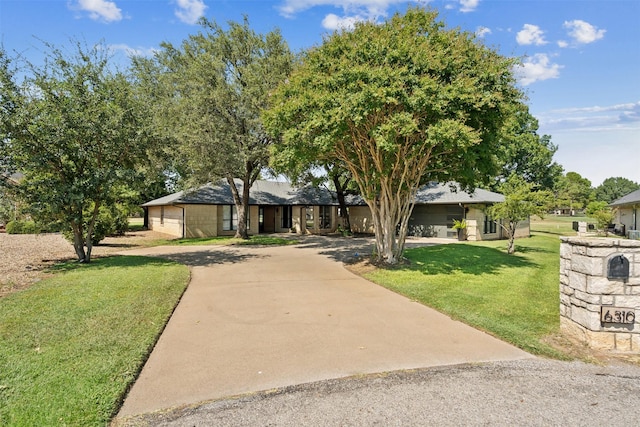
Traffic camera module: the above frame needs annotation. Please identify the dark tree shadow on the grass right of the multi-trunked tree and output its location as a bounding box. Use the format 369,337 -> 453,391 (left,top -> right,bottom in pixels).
404,244 -> 537,275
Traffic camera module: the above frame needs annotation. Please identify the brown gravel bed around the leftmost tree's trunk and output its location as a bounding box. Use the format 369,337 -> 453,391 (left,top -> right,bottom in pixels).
0,231 -> 171,297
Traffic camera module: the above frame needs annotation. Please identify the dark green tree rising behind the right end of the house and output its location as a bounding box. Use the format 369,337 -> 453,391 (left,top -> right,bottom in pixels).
493,105 -> 563,190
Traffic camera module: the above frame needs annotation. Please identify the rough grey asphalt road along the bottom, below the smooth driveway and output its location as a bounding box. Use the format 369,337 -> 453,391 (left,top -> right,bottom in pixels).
116,359 -> 640,427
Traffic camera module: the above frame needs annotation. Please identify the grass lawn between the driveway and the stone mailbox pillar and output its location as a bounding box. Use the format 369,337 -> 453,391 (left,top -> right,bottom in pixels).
365,234 -> 564,358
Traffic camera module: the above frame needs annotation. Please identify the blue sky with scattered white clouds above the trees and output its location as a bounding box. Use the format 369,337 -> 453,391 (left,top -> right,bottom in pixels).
0,0 -> 640,186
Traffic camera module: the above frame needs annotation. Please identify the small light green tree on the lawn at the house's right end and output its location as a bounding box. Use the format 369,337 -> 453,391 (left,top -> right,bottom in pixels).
487,175 -> 553,254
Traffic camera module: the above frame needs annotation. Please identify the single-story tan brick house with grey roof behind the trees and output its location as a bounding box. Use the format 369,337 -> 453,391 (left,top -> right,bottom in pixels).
142,181 -> 529,240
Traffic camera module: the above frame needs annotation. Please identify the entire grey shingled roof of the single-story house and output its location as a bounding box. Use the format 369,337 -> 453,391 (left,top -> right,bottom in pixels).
142,181 -> 504,207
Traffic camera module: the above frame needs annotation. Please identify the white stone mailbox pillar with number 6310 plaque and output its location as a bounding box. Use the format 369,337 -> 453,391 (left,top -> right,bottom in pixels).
560,237 -> 640,354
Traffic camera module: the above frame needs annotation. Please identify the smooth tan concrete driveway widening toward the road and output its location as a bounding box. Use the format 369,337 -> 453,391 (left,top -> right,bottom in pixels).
118,239 -> 533,418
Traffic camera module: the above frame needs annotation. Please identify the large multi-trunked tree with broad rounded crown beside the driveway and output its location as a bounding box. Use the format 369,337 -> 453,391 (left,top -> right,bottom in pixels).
265,8 -> 522,264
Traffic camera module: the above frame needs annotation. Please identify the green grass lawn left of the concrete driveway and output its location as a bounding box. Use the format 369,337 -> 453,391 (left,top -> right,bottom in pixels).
0,257 -> 189,426
